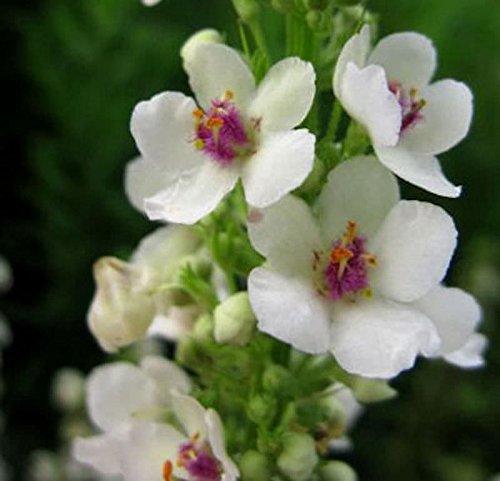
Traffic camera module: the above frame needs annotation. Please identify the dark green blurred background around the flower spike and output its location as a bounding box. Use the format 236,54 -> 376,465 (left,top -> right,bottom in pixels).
0,0 -> 500,481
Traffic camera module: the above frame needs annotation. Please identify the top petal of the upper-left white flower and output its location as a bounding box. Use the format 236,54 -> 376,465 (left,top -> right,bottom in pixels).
186,44 -> 255,110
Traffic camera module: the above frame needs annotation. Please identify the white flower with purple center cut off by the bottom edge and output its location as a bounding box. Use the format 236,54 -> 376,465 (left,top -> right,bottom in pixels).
114,394 -> 239,481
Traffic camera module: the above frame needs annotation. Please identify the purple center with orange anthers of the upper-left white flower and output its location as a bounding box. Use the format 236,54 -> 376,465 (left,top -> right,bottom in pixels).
189,91 -> 259,165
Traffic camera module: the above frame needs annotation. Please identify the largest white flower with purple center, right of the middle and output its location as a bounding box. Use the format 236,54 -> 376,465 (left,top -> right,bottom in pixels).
248,157 -> 464,378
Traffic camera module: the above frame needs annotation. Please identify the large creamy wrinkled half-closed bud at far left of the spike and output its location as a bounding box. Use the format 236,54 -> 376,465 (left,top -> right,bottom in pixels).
87,257 -> 155,352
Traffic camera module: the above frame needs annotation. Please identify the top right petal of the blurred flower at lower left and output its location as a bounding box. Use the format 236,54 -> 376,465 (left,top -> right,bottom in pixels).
140,356 -> 192,406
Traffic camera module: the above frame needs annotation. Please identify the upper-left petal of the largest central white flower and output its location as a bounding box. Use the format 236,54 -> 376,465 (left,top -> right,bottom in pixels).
248,195 -> 322,275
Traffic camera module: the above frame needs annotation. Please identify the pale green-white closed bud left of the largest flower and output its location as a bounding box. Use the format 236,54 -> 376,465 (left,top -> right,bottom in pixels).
214,292 -> 257,346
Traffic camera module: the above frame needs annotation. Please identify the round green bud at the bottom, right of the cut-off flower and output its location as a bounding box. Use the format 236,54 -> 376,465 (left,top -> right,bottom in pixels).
278,433 -> 318,481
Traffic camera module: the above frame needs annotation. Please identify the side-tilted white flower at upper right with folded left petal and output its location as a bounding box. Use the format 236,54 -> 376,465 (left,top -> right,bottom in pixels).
333,25 -> 472,197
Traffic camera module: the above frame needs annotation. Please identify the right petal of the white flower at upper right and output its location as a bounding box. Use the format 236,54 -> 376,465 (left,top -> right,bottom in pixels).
399,80 -> 473,154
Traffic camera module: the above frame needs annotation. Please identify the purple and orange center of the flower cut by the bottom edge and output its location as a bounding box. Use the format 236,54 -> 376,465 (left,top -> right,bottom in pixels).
163,434 -> 222,481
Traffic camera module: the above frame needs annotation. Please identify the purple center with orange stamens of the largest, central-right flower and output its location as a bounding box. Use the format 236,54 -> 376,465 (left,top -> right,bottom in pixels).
313,222 -> 376,301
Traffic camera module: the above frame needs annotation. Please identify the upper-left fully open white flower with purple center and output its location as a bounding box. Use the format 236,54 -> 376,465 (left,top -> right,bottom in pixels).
127,43 -> 315,224
